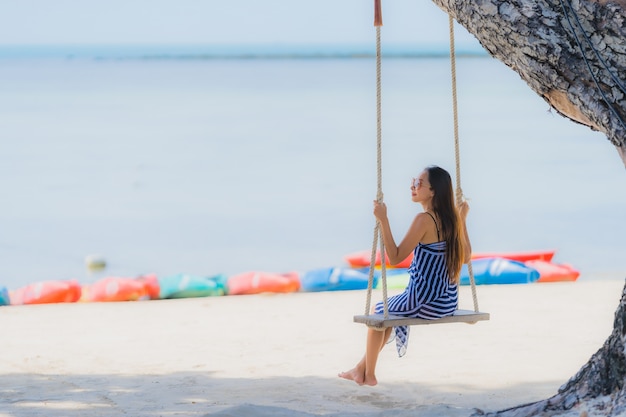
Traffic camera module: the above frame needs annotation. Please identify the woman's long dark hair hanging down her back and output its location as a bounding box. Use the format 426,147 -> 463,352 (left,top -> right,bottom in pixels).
426,165 -> 465,284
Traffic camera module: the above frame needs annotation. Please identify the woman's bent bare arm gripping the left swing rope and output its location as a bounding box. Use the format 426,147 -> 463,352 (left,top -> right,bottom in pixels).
374,201 -> 426,265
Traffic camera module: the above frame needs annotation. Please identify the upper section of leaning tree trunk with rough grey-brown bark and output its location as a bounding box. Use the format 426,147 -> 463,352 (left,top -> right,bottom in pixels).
433,0 -> 626,166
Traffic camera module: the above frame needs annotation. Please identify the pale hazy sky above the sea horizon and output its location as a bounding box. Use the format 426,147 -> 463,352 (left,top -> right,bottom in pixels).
0,0 -> 477,46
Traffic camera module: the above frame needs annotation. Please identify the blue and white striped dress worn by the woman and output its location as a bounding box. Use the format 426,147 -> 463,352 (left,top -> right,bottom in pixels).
375,241 -> 459,356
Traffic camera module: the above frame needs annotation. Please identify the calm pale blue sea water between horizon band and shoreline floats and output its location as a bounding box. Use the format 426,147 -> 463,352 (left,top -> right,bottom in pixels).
0,51 -> 626,288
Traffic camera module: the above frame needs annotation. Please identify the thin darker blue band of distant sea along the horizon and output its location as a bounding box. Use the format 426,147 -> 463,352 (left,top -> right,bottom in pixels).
0,43 -> 488,60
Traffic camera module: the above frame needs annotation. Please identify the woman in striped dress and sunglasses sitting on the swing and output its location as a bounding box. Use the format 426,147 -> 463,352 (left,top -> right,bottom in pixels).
339,166 -> 472,385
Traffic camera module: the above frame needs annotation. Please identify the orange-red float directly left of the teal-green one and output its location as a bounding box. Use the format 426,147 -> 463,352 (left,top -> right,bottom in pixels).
82,277 -> 148,301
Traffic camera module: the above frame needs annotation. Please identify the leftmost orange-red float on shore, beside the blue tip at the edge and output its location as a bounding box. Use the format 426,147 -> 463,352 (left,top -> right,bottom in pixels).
10,280 -> 82,305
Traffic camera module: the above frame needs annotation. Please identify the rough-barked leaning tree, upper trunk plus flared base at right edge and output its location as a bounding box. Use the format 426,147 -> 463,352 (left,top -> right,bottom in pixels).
424,0 -> 626,417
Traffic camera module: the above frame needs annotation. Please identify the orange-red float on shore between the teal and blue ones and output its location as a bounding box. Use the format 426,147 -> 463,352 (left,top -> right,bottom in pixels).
226,271 -> 300,295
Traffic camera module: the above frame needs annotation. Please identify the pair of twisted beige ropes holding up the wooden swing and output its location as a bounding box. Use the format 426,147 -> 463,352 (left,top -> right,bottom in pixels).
358,0 -> 479,318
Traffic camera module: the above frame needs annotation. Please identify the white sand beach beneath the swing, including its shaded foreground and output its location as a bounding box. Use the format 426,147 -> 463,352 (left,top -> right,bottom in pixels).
0,280 -> 623,417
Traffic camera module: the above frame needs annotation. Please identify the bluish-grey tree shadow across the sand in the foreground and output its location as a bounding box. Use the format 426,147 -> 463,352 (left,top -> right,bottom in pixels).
0,372 -> 556,417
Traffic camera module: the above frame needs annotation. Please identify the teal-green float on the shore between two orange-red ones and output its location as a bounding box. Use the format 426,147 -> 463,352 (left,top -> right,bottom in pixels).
158,274 -> 227,299
